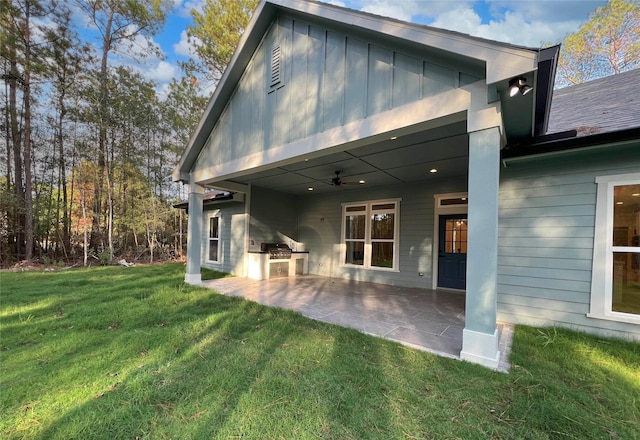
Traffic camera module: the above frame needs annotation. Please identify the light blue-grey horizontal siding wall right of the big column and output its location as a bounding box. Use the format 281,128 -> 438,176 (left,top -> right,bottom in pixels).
498,141 -> 640,339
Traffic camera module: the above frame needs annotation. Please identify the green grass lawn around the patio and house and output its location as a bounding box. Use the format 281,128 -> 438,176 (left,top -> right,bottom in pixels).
0,264 -> 640,439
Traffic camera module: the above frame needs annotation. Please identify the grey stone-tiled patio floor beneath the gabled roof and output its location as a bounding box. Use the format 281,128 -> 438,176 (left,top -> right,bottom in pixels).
202,275 -> 513,371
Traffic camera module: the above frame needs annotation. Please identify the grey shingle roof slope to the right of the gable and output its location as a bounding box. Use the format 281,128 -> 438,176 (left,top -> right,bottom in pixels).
547,69 -> 640,136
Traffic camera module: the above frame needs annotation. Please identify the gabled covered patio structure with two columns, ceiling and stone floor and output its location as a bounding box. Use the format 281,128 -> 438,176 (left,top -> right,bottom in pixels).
172,0 -> 558,369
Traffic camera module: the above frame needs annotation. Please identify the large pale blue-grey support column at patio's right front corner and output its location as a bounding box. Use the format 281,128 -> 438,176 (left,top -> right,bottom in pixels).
460,127 -> 500,368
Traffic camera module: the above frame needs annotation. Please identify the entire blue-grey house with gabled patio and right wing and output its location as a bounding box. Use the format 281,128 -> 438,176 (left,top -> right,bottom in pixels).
173,0 -> 640,368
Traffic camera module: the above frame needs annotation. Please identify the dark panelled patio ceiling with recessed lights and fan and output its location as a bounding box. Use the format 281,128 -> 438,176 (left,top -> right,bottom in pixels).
218,121 -> 469,195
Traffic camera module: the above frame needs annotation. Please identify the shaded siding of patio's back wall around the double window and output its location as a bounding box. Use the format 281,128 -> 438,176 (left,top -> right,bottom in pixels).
299,178 -> 466,289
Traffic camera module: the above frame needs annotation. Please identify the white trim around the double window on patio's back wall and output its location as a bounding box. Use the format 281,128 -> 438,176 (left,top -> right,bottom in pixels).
340,198 -> 402,272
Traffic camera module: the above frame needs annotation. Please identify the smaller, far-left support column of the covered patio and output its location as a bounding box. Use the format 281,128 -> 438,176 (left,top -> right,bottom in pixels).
184,183 -> 204,284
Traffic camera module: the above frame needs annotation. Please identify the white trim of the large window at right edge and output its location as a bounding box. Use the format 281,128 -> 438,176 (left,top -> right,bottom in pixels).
587,173 -> 640,324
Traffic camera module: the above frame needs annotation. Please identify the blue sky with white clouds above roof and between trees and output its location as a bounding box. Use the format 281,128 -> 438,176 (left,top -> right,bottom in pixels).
77,0 -> 606,96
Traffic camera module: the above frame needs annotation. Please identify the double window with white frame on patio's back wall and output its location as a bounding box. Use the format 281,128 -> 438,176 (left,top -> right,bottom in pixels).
342,200 -> 400,270
